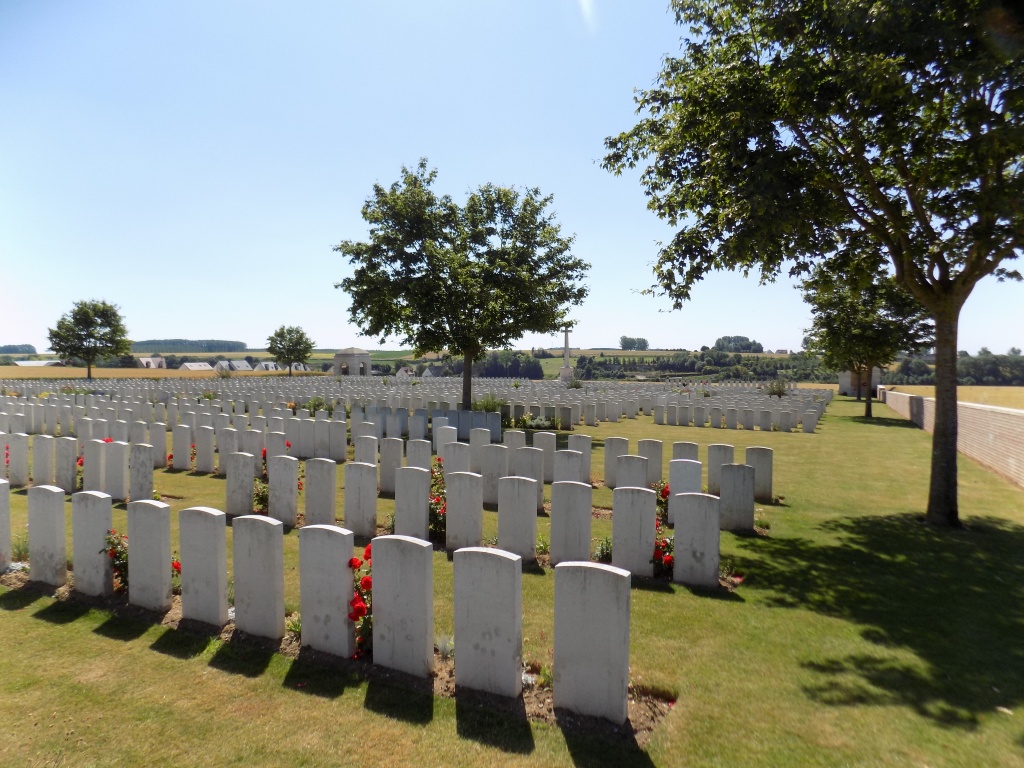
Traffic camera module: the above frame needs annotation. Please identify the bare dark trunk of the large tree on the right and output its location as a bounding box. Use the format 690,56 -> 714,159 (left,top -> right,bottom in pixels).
925,309 -> 959,527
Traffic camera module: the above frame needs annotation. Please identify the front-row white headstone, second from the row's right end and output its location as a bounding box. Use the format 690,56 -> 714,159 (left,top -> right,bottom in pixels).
453,547 -> 522,696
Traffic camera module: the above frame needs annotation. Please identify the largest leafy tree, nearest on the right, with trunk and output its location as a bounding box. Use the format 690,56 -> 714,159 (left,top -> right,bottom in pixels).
604,0 -> 1024,525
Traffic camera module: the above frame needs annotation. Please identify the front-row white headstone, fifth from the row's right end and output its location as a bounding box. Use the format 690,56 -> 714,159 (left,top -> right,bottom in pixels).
230,515 -> 285,640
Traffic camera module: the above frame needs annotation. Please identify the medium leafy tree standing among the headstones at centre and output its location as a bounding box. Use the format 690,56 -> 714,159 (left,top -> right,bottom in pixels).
334,160 -> 589,410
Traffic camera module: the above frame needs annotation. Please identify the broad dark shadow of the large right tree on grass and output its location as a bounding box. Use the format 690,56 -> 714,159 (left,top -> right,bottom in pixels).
733,515 -> 1024,729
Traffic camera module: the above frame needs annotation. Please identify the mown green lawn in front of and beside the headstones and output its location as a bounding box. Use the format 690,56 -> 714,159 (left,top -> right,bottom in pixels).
0,397 -> 1024,768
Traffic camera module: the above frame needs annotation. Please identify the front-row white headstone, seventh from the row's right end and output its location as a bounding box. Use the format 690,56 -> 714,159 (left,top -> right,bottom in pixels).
128,499 -> 171,610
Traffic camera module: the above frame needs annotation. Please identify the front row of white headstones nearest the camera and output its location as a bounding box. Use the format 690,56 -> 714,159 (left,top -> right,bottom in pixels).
8,481 -> 630,723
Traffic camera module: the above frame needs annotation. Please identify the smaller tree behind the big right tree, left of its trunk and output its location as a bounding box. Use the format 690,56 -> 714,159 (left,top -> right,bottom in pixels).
802,260 -> 934,419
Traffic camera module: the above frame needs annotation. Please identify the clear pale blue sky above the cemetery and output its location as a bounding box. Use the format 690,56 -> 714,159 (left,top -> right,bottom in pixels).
0,0 -> 1024,352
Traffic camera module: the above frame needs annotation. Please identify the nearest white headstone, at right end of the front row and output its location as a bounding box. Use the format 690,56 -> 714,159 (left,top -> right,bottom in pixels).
553,562 -> 630,724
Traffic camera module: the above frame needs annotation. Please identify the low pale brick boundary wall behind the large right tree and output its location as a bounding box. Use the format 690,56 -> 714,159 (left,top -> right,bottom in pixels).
879,387 -> 1024,487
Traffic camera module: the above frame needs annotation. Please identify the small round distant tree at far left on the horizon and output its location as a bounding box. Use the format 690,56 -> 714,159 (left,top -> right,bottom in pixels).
47,300 -> 131,379
